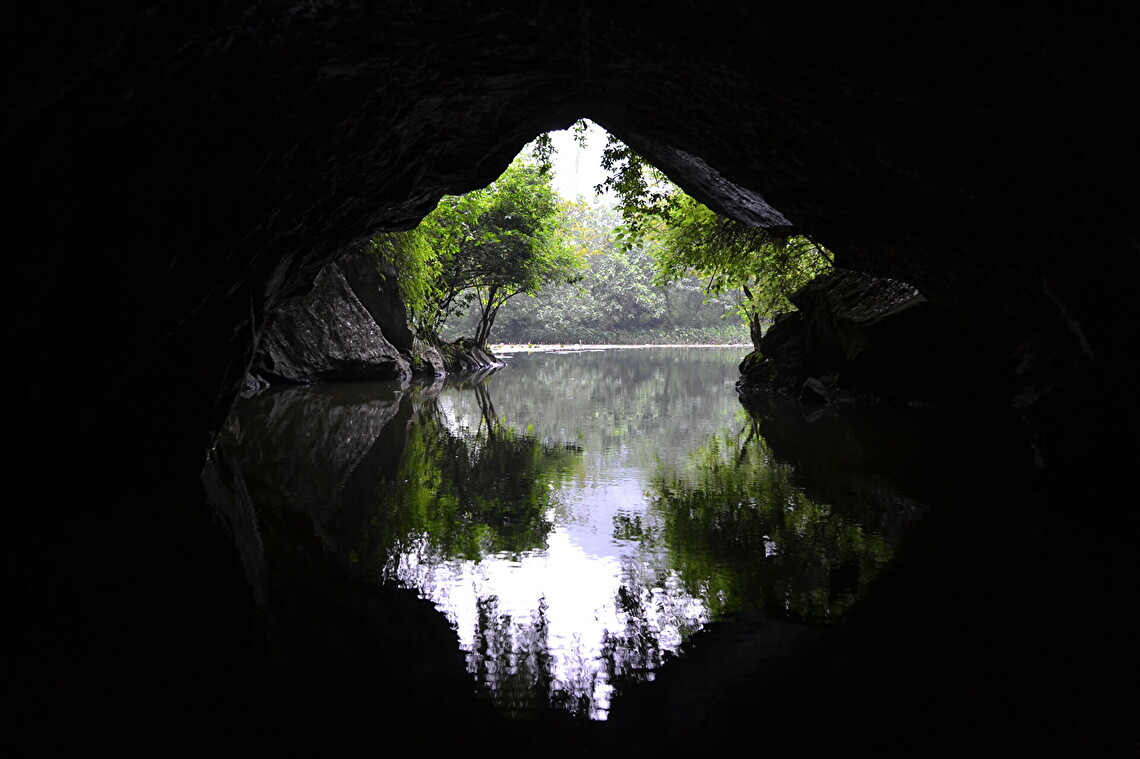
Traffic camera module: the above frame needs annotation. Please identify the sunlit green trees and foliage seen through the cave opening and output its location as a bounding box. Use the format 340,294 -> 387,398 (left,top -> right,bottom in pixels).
373,122 -> 831,344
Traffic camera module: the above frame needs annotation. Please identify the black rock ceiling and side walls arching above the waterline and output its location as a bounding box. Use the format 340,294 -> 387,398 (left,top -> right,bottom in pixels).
3,1 -> 1137,478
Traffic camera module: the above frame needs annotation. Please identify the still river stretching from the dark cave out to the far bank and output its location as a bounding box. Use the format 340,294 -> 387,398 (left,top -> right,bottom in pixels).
207,348 -> 1048,747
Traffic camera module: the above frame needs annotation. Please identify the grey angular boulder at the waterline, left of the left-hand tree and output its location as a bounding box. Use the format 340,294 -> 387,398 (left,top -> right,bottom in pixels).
251,254 -> 410,383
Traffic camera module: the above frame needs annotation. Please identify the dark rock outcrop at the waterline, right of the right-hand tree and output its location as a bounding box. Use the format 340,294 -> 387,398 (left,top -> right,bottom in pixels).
738,265 -> 1012,407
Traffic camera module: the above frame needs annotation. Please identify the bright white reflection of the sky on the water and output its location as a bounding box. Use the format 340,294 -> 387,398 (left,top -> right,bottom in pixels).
398,470 -> 708,719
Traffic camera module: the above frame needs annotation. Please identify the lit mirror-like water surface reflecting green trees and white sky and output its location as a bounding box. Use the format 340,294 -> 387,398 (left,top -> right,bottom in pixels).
220,349 -> 918,719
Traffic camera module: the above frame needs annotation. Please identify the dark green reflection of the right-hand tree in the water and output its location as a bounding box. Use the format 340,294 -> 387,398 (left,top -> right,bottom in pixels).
650,419 -> 891,621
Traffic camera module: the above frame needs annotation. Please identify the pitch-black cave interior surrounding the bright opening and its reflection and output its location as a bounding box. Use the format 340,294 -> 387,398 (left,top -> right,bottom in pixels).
3,0 -> 1140,756
